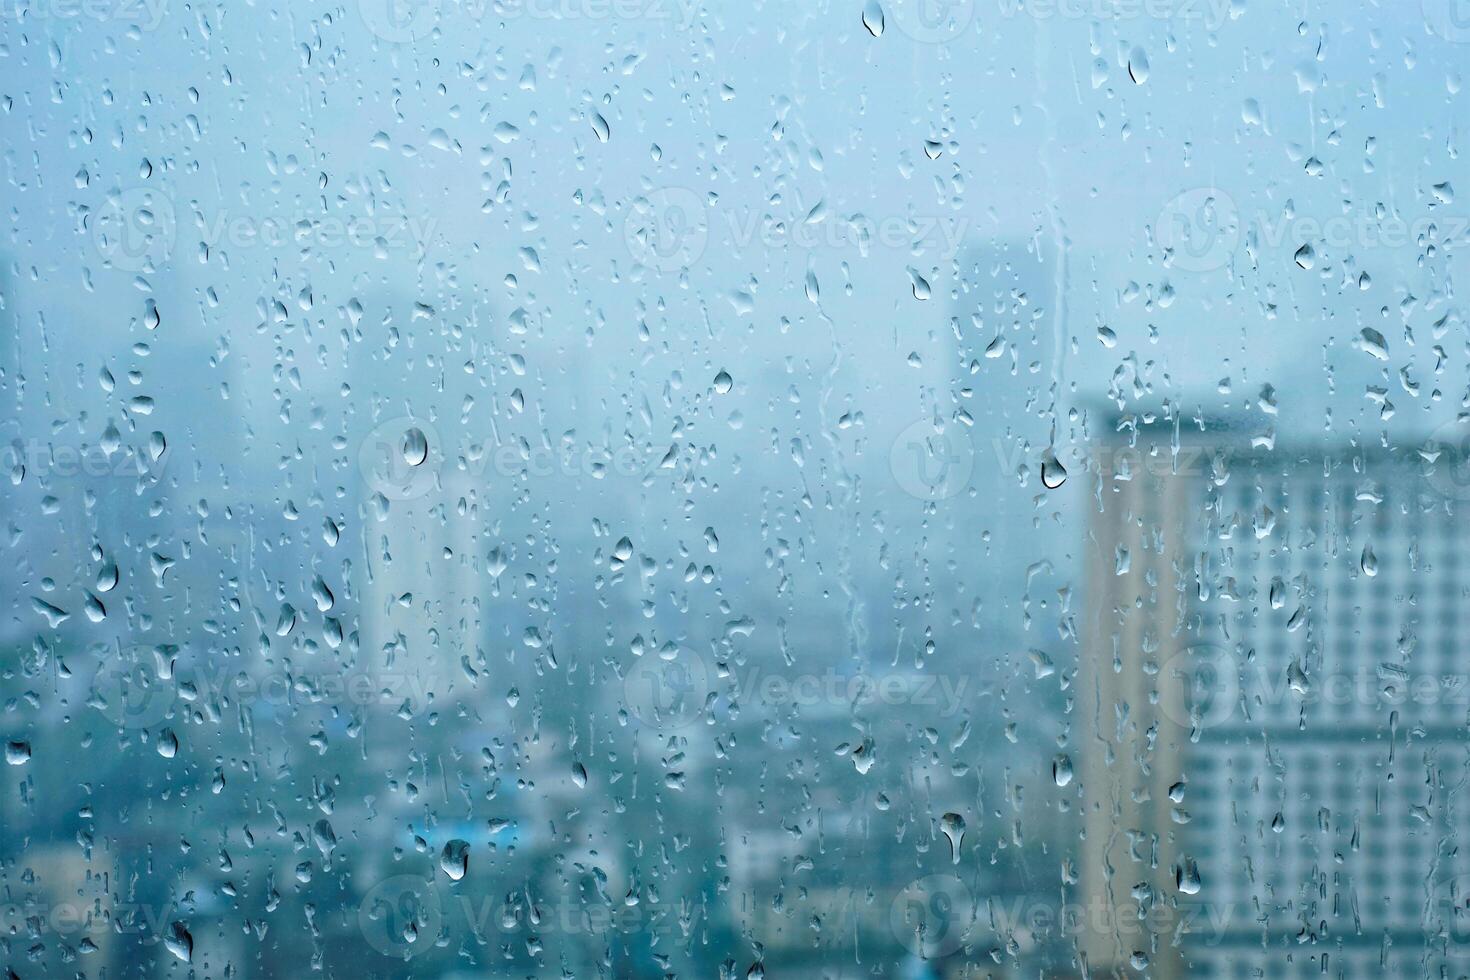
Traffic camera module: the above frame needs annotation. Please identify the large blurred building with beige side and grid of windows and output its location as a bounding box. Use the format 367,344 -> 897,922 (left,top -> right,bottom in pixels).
1079,419 -> 1470,979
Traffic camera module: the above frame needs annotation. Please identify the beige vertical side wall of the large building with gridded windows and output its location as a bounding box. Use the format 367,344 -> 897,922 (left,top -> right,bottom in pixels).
1073,408 -> 1214,976
